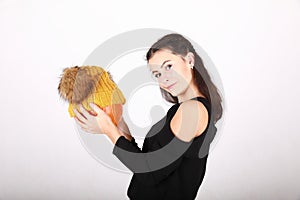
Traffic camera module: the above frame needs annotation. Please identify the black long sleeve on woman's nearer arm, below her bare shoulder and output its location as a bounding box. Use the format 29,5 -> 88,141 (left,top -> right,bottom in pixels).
113,136 -> 191,185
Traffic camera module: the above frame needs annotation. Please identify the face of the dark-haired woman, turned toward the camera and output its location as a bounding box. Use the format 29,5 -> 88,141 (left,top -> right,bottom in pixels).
148,50 -> 193,96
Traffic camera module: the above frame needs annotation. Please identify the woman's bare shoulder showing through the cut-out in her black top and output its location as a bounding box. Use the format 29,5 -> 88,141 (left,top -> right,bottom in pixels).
170,100 -> 208,142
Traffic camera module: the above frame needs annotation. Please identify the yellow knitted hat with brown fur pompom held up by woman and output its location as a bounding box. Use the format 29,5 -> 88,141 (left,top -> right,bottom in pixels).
58,66 -> 126,117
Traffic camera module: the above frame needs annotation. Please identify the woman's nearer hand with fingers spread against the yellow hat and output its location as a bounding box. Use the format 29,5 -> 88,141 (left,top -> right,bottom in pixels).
74,103 -> 116,135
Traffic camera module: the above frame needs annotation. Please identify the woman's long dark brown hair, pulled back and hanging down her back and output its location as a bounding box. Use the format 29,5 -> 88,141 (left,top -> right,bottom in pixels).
146,33 -> 223,124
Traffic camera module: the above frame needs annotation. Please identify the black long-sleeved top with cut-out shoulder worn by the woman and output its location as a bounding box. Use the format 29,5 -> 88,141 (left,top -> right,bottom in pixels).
113,97 -> 217,200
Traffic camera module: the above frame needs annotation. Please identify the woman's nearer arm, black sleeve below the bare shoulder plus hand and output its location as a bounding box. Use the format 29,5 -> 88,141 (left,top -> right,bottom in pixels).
74,106 -> 196,185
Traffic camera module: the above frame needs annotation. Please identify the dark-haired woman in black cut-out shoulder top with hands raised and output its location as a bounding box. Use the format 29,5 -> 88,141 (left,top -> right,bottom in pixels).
74,34 -> 222,200
